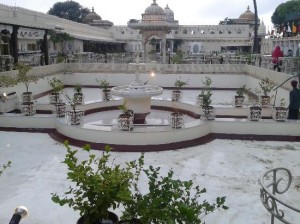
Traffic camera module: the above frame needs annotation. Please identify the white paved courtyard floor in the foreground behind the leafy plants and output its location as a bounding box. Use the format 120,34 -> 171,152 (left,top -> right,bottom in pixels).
0,89 -> 300,224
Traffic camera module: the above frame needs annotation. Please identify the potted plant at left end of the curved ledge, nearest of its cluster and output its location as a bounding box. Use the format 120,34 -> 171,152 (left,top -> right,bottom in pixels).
64,92 -> 84,125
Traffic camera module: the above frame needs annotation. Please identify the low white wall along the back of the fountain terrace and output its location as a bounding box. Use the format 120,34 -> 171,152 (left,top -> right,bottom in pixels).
0,63 -> 291,105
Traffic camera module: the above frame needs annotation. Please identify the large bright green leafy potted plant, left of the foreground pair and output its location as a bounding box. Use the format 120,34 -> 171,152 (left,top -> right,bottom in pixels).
52,141 -> 139,224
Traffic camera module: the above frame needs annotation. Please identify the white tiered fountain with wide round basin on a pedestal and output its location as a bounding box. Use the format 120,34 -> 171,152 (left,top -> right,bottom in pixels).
111,52 -> 163,124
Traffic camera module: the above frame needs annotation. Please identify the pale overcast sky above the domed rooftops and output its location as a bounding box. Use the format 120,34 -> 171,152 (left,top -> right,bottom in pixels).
0,0 -> 287,28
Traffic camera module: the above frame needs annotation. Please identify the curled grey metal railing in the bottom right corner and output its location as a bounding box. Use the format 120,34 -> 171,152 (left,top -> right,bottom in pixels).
259,168 -> 300,224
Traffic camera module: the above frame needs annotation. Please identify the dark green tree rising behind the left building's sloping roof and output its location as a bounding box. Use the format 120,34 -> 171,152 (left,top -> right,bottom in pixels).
48,0 -> 91,23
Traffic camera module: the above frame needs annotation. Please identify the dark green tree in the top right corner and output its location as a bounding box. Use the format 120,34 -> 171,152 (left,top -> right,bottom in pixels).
271,0 -> 300,25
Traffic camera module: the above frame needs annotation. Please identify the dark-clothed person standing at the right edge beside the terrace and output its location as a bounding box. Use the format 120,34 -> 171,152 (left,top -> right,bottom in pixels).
288,80 -> 300,120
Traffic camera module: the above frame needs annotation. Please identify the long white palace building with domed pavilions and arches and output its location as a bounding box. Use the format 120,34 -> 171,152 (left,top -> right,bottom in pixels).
0,0 -> 272,68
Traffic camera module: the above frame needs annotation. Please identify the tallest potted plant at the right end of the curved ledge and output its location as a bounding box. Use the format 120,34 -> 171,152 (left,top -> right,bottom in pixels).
197,77 -> 215,120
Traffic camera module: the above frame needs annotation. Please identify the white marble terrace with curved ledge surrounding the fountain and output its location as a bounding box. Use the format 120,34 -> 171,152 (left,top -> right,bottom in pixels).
0,64 -> 300,151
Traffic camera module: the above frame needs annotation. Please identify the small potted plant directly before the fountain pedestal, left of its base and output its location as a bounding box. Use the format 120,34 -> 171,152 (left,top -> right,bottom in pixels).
118,101 -> 134,131
